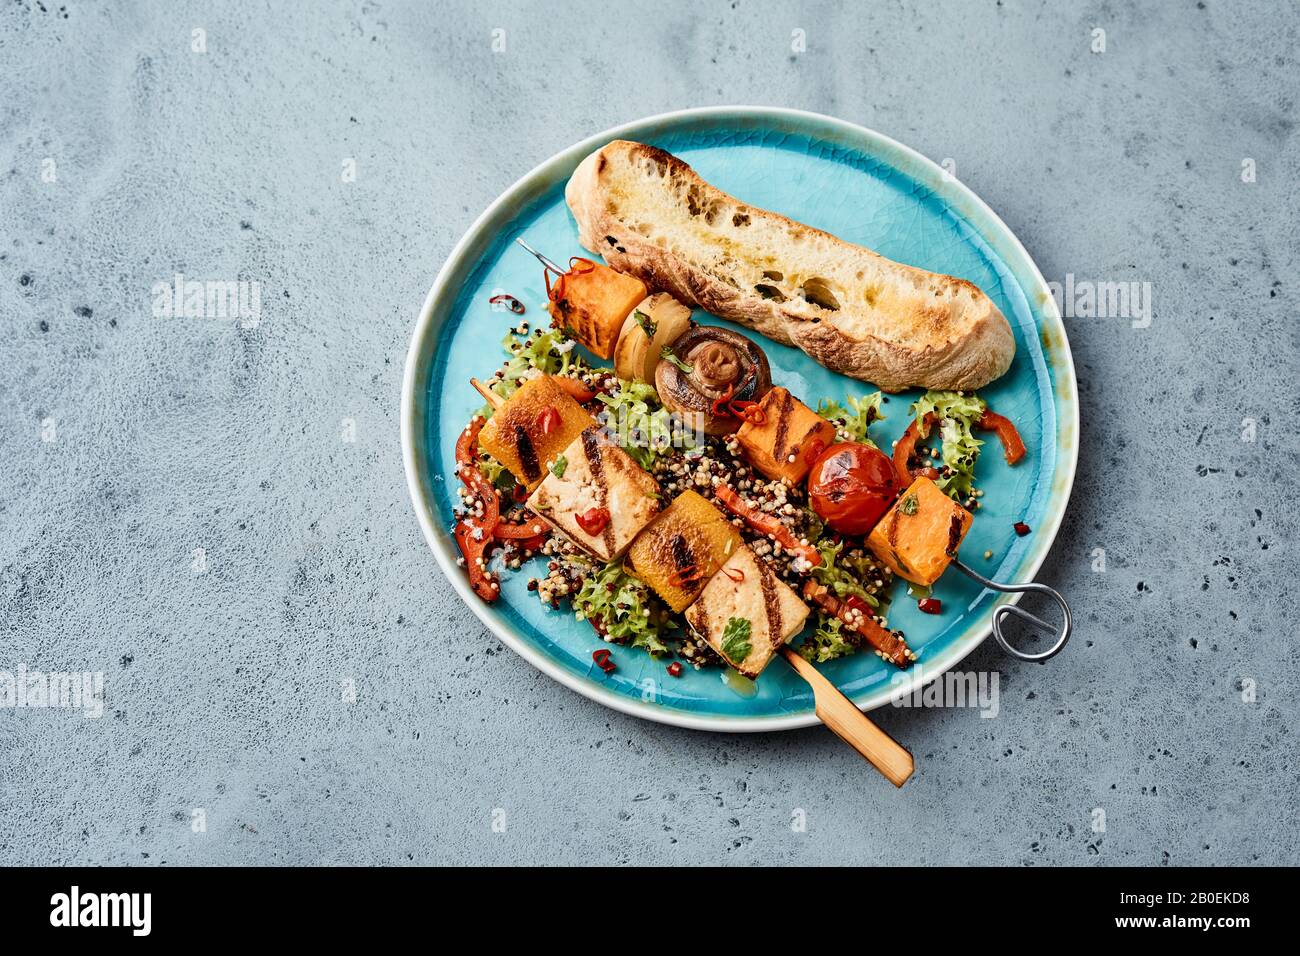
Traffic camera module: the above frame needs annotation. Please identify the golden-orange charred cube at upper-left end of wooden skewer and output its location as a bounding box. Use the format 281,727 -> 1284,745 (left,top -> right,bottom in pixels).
478,375 -> 595,490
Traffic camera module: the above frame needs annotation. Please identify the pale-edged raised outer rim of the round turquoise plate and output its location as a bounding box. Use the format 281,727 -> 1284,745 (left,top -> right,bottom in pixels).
400,107 -> 1079,732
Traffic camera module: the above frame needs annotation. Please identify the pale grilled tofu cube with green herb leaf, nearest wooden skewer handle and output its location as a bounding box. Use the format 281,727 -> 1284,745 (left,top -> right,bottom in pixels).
686,545 -> 809,678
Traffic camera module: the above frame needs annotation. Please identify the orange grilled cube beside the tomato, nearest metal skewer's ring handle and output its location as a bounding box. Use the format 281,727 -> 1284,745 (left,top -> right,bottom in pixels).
867,477 -> 974,587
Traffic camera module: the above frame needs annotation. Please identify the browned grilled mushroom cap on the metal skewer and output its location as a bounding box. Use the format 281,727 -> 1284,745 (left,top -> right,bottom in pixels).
654,325 -> 772,436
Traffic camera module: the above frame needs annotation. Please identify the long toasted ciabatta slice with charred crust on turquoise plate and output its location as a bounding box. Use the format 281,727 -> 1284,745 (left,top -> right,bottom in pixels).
564,139 -> 1015,392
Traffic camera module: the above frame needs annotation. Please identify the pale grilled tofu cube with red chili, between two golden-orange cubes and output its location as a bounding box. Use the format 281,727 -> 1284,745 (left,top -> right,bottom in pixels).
528,427 -> 663,562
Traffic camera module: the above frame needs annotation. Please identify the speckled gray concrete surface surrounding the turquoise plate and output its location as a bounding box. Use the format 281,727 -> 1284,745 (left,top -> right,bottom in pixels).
0,0 -> 1300,865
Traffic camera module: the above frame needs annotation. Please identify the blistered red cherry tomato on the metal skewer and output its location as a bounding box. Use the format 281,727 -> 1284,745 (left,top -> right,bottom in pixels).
809,441 -> 898,537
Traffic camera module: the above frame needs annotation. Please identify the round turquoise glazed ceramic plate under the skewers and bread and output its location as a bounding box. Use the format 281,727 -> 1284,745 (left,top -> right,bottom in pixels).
402,108 -> 1079,731
